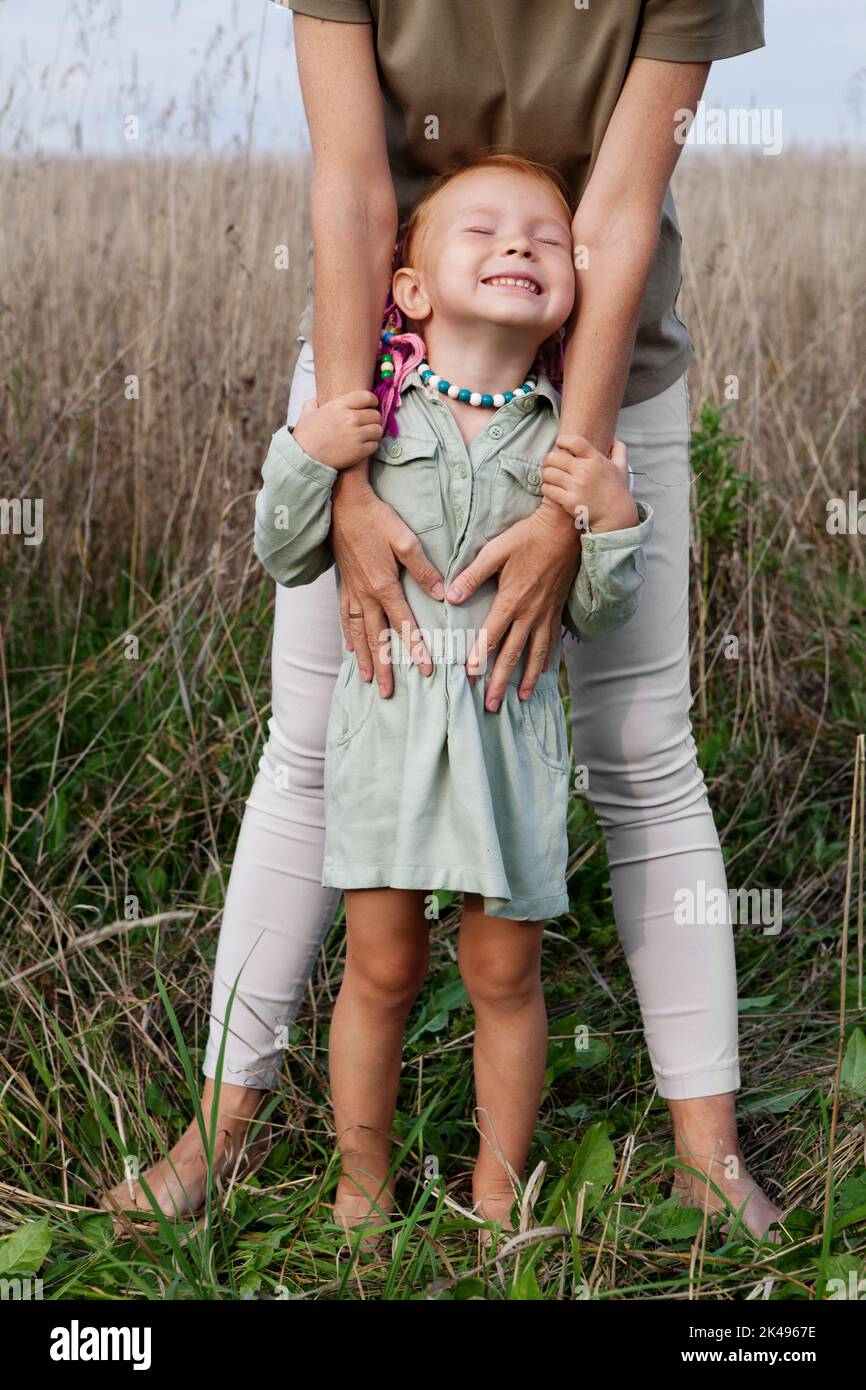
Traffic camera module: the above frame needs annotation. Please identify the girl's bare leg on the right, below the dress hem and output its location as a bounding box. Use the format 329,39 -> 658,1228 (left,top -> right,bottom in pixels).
457,892 -> 548,1225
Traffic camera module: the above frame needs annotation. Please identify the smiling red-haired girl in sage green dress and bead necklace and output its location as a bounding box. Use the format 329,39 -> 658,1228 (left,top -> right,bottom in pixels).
256,156 -> 652,1245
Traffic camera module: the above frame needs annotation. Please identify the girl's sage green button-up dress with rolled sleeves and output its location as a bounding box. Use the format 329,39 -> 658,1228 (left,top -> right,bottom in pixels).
256,371 -> 652,922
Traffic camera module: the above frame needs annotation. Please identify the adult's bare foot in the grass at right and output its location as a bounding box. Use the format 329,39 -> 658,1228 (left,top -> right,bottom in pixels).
667,1091 -> 784,1243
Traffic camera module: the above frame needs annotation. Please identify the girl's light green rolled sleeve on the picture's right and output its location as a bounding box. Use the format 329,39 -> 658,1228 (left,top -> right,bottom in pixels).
563,502 -> 652,642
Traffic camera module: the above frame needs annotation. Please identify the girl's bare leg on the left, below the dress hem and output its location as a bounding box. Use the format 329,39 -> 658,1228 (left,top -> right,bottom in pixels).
328,888 -> 430,1245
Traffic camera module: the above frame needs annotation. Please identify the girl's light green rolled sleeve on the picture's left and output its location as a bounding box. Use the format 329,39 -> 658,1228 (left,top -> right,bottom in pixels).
254,425 -> 338,588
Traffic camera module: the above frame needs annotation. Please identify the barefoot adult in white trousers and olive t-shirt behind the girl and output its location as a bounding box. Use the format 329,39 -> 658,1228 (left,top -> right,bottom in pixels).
104,0 -> 778,1234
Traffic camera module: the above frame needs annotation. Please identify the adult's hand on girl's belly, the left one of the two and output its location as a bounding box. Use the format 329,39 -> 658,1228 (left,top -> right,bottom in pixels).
331,467 -> 445,696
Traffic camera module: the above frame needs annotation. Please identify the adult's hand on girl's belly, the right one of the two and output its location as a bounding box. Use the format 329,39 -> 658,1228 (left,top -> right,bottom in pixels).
446,498 -> 580,710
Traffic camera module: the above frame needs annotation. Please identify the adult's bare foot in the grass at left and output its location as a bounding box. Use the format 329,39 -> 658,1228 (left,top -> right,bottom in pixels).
99,1077 -> 270,1220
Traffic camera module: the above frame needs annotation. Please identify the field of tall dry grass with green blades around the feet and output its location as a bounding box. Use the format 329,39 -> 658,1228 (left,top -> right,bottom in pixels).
0,152 -> 866,1300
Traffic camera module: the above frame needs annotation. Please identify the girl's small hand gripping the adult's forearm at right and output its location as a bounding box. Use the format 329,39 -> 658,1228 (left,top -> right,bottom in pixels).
541,435 -> 639,532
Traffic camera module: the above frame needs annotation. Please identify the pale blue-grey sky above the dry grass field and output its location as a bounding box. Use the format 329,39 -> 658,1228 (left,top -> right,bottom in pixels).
0,0 -> 866,154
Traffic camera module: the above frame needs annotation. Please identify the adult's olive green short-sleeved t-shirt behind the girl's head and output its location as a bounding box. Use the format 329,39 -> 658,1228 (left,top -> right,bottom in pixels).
277,0 -> 765,406
